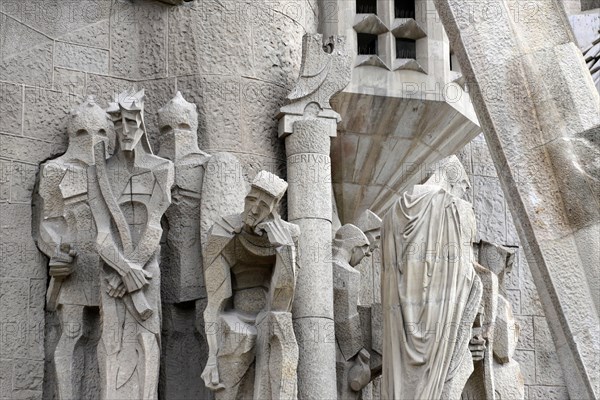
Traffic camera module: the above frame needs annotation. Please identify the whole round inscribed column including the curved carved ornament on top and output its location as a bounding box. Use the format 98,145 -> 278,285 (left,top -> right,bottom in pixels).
279,34 -> 352,400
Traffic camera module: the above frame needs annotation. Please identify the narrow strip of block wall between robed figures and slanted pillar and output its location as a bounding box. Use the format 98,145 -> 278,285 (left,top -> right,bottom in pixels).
457,135 -> 569,400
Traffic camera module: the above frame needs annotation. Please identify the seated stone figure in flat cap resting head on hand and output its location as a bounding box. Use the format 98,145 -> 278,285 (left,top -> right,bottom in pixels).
202,171 -> 300,400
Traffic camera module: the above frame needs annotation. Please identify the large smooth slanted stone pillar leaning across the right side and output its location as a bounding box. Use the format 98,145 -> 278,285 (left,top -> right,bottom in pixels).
435,0 -> 600,399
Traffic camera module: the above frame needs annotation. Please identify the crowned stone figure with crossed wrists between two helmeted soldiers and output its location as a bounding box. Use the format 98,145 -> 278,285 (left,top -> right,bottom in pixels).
88,90 -> 174,399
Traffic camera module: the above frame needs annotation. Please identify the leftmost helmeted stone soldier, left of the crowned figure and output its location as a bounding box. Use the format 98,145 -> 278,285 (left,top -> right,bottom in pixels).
37,98 -> 110,399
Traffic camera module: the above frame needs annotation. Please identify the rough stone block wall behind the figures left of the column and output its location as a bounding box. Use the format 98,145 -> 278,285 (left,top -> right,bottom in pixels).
0,0 -> 317,399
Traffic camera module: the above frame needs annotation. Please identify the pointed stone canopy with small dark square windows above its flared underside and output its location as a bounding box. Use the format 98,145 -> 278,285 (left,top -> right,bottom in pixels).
324,0 -> 481,225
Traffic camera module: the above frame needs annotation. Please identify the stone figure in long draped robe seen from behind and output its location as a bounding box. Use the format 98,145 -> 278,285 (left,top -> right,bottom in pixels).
381,156 -> 482,399
